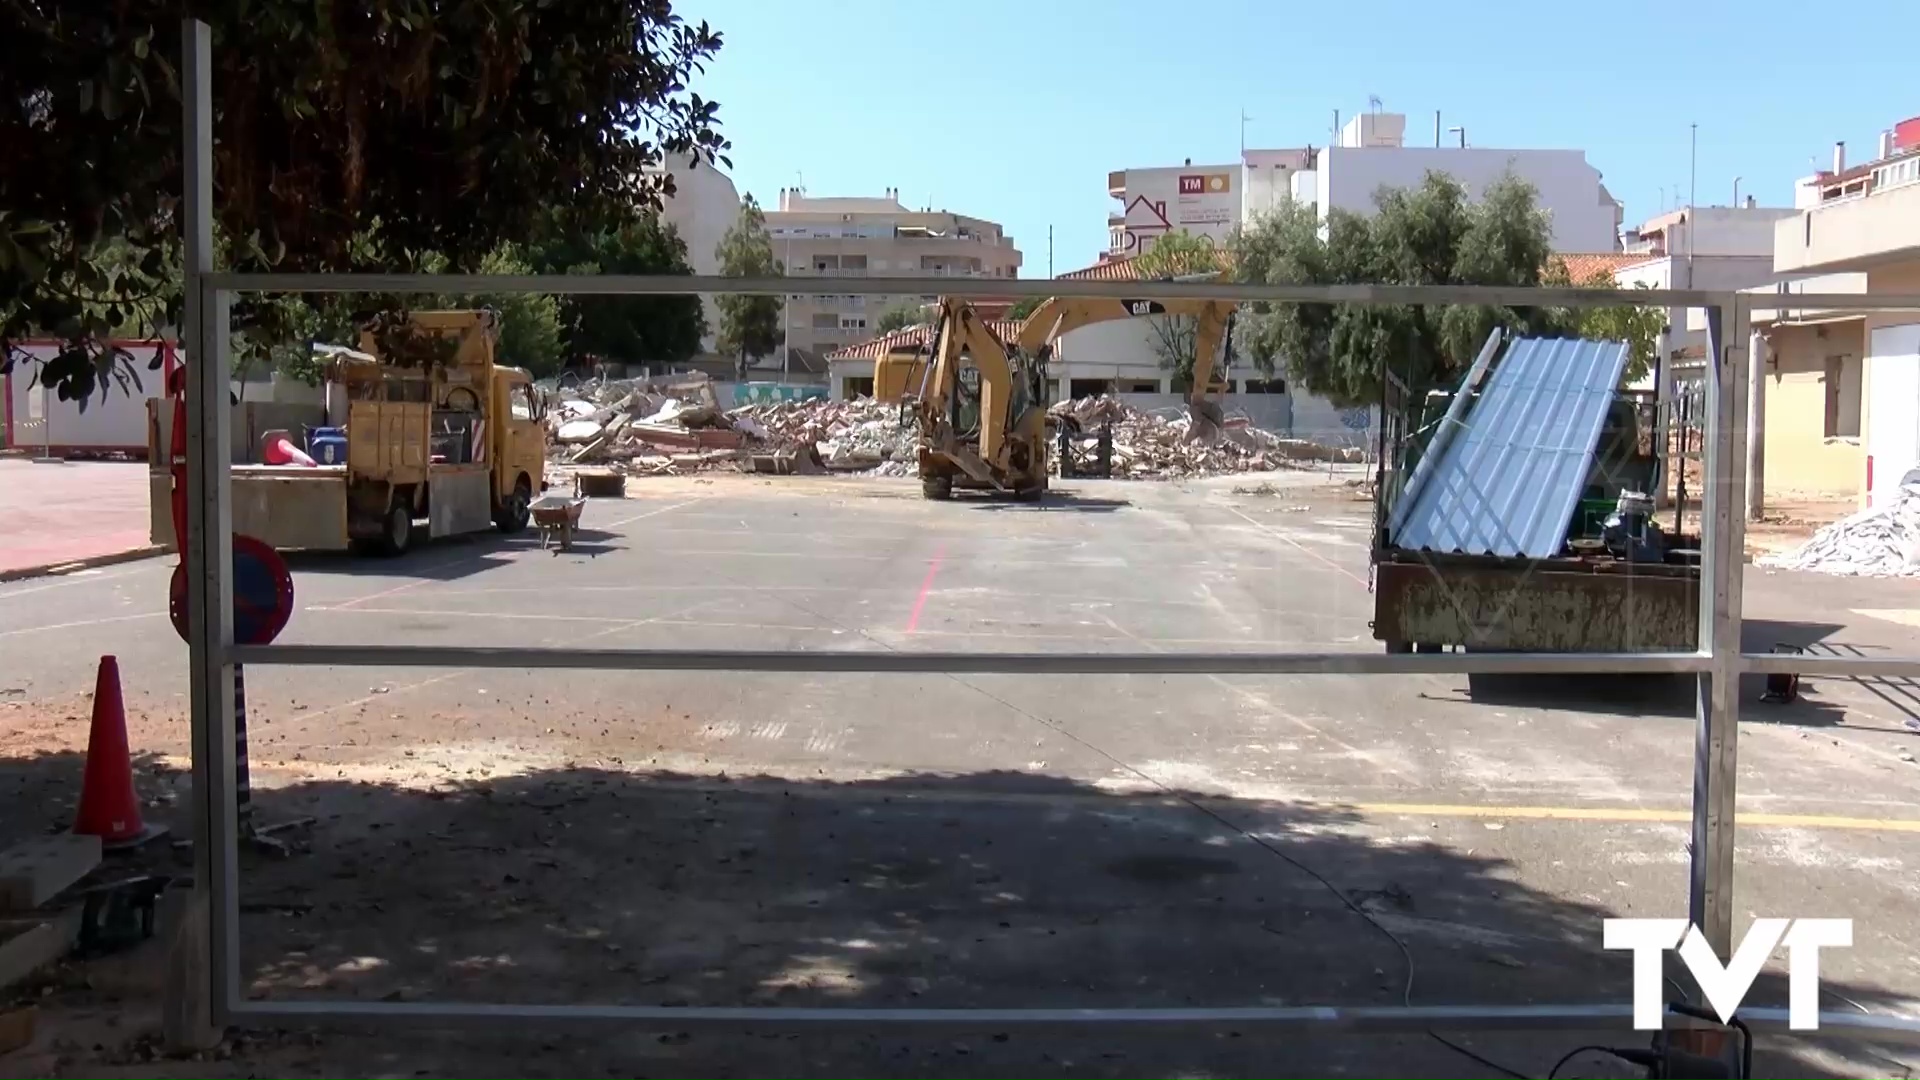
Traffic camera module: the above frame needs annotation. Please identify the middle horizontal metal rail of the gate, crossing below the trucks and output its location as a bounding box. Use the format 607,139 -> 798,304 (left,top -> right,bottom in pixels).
230,646 -> 1711,675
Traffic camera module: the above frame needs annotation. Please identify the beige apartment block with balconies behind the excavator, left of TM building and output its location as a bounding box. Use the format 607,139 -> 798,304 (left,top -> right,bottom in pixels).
766,188 -> 1020,361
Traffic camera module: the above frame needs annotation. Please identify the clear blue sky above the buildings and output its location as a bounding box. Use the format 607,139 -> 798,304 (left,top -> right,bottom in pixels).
691,0 -> 1920,277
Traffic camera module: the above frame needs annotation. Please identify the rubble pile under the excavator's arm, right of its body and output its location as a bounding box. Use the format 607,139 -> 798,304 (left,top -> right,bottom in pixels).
1048,396 -> 1361,479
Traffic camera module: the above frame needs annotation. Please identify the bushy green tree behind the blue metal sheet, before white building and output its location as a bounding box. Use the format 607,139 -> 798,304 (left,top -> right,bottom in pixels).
1233,173 -> 1565,405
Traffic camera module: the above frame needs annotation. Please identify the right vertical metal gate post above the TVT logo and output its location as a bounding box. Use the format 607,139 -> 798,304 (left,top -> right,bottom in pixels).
1688,296 -> 1749,949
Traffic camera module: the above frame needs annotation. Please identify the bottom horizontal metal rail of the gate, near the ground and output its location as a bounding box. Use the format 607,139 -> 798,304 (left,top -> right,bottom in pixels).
230,999 -> 1920,1043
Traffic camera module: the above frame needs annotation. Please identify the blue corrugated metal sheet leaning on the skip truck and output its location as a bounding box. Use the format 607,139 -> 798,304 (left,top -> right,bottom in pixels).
1392,338 -> 1626,559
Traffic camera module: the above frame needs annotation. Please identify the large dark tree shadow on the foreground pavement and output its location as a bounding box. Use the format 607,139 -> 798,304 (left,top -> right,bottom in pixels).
0,749 -> 1920,1080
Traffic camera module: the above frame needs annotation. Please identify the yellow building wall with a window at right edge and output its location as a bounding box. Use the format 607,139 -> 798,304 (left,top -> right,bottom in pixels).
1766,321 -> 1866,496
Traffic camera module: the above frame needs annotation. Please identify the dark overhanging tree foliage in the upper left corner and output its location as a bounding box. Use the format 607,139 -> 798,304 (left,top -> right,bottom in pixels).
0,0 -> 728,400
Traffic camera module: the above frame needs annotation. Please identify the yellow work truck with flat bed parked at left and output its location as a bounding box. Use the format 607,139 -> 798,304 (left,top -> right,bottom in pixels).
148,311 -> 547,555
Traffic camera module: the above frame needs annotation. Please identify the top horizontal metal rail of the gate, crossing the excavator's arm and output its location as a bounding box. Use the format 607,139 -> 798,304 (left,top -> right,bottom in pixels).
205,273 -> 1743,307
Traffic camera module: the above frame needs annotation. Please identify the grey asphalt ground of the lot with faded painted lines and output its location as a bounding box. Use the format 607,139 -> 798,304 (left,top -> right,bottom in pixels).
0,475 -> 1920,1076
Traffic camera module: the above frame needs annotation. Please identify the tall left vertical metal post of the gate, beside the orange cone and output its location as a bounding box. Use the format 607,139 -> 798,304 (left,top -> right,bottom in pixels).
177,19 -> 240,1030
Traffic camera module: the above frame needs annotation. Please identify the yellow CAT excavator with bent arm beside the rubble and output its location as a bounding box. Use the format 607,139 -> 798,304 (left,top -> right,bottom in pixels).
874,296 -> 1233,500
